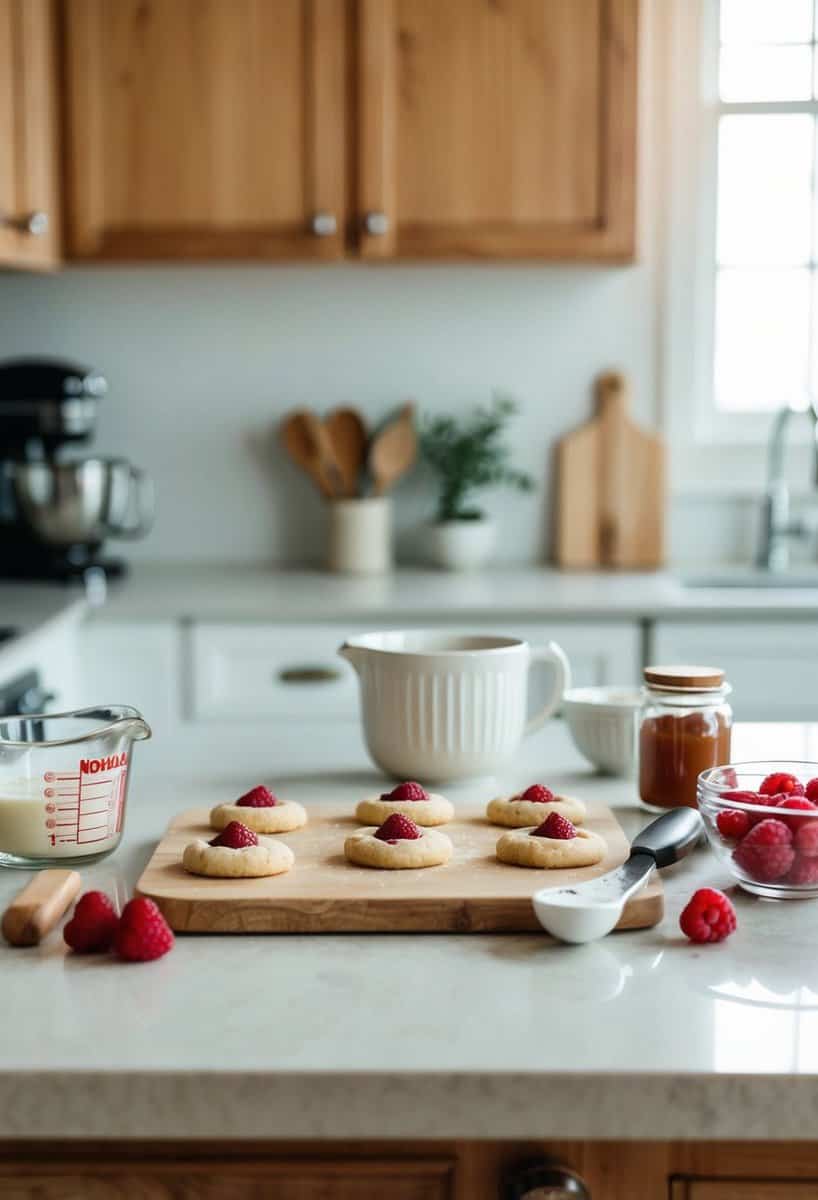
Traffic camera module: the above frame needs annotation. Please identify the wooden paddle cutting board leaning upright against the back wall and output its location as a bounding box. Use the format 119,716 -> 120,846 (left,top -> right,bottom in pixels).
557,371 -> 664,569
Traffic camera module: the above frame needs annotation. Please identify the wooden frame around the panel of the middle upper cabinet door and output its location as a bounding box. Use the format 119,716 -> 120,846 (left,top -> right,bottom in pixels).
65,0 -> 348,260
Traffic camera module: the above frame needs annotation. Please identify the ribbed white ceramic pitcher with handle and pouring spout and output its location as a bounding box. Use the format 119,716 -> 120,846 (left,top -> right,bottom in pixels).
338,630 -> 571,782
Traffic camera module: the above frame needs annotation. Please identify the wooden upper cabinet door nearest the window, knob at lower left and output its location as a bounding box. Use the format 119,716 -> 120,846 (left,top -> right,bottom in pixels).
357,0 -> 637,260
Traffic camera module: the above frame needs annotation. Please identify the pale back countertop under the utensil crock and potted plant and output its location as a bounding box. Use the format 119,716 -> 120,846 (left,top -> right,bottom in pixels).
87,564 -> 818,624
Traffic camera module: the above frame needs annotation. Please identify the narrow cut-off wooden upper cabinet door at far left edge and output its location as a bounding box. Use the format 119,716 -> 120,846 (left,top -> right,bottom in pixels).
0,0 -> 60,269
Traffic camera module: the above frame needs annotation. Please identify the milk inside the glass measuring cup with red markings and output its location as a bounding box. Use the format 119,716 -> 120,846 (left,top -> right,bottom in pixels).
0,755 -> 126,858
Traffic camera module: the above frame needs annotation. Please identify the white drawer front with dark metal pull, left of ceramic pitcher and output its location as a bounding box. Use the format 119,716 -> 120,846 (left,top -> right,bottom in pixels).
190,624 -> 362,720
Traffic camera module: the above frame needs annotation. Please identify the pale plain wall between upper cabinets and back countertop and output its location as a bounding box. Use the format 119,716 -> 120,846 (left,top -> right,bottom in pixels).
0,263 -> 675,562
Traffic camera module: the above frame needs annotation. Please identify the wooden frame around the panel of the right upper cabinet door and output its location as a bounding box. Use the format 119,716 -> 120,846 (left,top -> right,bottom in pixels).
356,0 -> 638,262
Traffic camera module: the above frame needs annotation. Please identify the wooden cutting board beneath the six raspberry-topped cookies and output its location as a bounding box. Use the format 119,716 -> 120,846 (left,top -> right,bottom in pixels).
137,804 -> 663,934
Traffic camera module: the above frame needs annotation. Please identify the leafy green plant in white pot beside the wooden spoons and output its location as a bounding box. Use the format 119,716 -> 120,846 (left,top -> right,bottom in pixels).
420,396 -> 533,571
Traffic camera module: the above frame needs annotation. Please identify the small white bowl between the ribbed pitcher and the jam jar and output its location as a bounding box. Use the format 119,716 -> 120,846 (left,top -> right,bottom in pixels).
563,688 -> 642,779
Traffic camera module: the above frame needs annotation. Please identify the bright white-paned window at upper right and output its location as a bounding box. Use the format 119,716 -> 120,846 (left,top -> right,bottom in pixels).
705,0 -> 818,415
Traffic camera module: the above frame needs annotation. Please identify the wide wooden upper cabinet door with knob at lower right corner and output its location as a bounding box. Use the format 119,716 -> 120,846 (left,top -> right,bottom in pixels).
66,0 -> 345,259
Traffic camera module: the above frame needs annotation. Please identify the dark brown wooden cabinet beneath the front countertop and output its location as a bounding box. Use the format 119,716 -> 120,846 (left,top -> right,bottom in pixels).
0,1141 -> 818,1200
